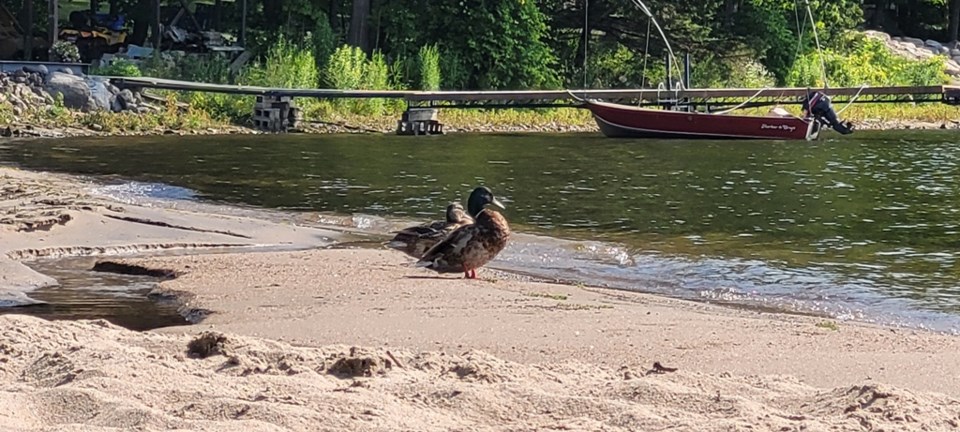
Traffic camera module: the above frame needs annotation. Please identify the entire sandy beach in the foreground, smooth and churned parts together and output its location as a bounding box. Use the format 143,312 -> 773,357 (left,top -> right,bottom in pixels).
0,164 -> 960,431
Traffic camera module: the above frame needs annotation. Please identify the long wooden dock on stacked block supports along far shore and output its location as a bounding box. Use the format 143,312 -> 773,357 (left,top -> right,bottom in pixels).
109,77 -> 960,135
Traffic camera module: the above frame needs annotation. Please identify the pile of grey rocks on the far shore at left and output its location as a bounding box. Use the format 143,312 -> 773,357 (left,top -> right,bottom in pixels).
0,65 -> 152,116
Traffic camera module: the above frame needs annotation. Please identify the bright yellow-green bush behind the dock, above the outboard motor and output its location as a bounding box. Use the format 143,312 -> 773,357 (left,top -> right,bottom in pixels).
787,33 -> 947,87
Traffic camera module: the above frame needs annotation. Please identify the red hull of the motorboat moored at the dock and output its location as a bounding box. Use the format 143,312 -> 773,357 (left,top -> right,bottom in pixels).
586,101 -> 819,140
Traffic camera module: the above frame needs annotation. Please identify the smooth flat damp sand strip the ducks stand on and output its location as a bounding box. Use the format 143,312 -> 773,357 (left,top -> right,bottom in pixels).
125,249 -> 960,396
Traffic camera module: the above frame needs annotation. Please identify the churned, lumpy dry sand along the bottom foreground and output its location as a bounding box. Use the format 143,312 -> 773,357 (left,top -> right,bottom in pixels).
0,316 -> 960,431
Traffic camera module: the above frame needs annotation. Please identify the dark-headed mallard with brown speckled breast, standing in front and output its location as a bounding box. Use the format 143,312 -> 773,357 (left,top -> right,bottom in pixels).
417,186 -> 510,279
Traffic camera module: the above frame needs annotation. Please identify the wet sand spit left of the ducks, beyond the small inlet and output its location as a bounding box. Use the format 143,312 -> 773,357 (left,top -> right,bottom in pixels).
0,167 -> 342,302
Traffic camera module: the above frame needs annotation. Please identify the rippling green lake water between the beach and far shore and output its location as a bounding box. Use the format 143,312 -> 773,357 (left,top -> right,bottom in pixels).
0,131 -> 960,331
